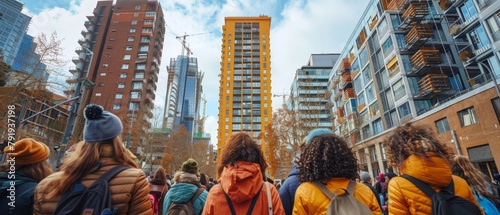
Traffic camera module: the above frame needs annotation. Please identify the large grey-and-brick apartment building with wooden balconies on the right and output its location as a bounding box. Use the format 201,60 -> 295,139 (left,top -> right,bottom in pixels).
328,0 -> 500,178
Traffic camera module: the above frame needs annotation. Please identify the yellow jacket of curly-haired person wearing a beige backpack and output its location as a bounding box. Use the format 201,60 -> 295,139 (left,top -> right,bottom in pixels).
292,178 -> 382,215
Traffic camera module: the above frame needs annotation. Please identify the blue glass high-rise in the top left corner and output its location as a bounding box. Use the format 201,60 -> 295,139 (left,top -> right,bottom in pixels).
0,0 -> 31,65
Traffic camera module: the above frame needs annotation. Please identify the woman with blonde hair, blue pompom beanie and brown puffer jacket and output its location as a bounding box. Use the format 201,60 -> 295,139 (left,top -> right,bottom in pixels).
33,104 -> 152,215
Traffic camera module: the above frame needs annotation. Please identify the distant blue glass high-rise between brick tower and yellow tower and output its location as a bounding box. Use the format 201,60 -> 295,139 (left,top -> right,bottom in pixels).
164,56 -> 203,134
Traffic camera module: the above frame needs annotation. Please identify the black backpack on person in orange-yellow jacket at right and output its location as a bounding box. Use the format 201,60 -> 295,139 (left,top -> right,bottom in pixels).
403,175 -> 481,215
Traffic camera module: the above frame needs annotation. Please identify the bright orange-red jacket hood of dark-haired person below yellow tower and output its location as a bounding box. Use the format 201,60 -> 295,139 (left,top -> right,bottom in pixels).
220,161 -> 263,203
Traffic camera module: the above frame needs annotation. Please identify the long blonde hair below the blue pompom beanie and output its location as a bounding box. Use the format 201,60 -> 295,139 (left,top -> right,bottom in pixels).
47,136 -> 138,199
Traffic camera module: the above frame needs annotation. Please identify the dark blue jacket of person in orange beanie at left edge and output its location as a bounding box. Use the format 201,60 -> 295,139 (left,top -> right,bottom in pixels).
0,172 -> 38,215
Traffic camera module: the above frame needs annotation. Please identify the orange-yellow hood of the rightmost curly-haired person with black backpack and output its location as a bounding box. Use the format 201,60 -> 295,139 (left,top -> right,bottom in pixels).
401,152 -> 452,187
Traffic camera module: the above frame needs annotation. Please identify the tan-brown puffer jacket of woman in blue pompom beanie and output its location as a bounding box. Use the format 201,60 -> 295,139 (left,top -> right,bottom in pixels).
33,157 -> 153,215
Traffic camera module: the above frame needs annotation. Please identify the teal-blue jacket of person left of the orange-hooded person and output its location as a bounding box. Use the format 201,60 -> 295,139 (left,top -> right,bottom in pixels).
163,183 -> 208,215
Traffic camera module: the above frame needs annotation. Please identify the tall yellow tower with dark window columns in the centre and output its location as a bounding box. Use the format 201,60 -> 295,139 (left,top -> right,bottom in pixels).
217,15 -> 272,163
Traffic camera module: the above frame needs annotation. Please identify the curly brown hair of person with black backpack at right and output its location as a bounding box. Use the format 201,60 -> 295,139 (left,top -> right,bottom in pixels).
386,123 -> 451,167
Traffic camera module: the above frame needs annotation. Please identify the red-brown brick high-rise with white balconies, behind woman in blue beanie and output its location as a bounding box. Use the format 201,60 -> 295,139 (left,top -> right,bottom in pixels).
69,0 -> 165,146
